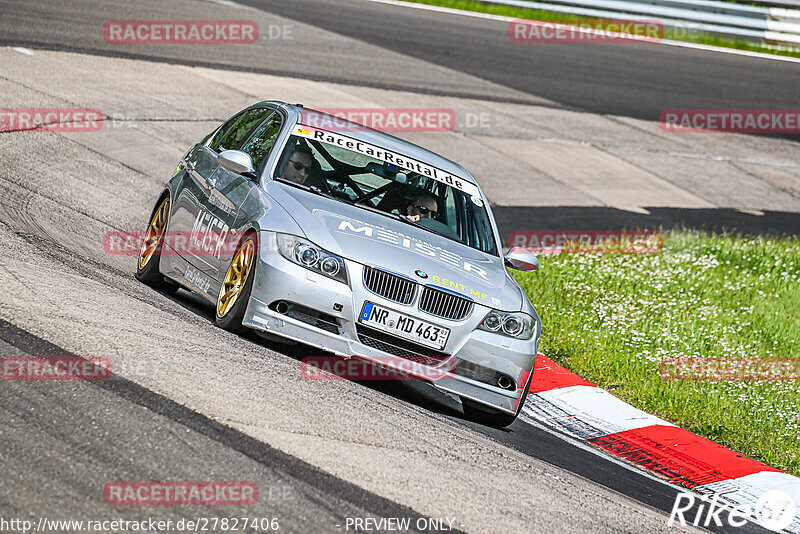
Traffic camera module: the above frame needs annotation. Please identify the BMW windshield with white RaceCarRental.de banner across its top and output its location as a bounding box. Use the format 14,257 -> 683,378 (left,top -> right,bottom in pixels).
275,125 -> 497,256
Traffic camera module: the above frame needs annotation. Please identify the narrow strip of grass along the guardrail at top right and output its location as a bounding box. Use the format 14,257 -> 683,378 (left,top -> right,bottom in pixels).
406,0 -> 800,57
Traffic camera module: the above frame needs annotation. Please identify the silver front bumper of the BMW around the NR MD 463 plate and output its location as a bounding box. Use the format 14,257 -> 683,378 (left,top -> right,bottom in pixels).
243,232 -> 538,414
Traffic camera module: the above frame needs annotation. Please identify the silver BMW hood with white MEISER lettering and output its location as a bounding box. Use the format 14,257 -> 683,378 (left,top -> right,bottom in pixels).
267,181 -> 522,311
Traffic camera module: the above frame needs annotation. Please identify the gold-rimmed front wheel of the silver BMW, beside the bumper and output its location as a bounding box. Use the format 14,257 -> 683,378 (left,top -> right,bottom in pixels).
215,233 -> 258,332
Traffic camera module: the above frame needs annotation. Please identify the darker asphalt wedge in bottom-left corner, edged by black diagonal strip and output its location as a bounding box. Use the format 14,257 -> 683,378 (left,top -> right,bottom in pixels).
0,320 -> 457,532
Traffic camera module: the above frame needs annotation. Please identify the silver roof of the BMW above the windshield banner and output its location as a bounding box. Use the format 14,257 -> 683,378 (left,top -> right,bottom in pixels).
262,100 -> 478,185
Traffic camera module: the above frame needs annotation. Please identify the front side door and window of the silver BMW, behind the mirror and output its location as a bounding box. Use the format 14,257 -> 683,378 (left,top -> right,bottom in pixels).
197,108 -> 283,280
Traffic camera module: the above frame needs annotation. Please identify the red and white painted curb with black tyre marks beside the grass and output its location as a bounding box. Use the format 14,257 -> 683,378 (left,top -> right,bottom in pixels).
522,354 -> 800,534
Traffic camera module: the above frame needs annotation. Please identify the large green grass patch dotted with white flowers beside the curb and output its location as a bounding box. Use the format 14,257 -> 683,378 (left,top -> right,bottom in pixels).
517,232 -> 800,475
